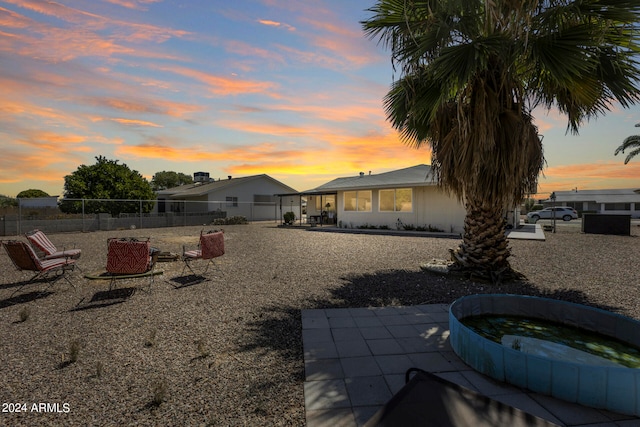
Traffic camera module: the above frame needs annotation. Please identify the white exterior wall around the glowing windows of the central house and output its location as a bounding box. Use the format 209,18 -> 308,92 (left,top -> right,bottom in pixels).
337,186 -> 466,233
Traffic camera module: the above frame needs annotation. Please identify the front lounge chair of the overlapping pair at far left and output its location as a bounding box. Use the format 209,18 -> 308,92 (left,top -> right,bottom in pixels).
2,240 -> 76,293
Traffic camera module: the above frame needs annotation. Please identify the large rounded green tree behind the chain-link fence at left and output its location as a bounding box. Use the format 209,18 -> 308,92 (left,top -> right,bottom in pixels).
60,156 -> 155,215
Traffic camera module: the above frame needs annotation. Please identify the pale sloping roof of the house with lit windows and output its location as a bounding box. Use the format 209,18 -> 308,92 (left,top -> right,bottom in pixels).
304,164 -> 436,194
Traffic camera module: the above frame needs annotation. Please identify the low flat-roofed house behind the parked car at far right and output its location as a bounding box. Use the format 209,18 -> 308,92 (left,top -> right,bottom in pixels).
543,188 -> 640,218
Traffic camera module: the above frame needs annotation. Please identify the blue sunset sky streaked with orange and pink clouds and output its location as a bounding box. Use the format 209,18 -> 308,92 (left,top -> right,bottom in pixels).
0,0 -> 640,197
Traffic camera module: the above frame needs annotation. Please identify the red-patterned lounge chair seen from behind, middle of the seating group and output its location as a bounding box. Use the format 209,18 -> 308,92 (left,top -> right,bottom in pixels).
107,238 -> 158,289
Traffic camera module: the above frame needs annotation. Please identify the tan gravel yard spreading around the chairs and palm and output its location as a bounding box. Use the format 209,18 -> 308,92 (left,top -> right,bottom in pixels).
0,223 -> 640,426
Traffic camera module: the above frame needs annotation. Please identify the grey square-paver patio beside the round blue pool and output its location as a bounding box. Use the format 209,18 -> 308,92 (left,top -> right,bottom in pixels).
302,304 -> 640,427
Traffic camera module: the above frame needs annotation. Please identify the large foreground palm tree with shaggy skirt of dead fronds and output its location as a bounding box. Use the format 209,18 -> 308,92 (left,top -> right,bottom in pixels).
362,0 -> 640,283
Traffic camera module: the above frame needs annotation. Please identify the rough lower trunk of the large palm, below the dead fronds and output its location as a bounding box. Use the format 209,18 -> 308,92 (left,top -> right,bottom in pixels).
451,199 -> 523,284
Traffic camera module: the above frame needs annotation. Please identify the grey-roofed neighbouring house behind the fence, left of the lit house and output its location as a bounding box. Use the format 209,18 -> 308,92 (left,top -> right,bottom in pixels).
157,172 -> 300,221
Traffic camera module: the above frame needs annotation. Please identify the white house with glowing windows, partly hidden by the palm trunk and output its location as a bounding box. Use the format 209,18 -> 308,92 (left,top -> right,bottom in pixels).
300,164 -> 466,233
